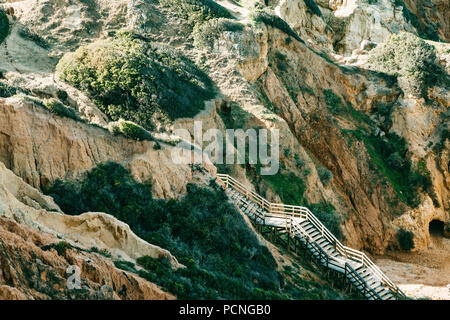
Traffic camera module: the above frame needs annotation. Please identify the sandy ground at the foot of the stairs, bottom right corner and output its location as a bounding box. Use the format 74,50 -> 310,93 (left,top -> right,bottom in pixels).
375,236 -> 450,300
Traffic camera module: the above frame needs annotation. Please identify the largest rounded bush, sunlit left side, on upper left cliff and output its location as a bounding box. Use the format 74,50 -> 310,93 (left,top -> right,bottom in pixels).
56,32 -> 215,130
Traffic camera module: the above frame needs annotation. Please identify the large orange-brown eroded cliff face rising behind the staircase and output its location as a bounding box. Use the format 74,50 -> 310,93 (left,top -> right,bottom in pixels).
199,10 -> 450,253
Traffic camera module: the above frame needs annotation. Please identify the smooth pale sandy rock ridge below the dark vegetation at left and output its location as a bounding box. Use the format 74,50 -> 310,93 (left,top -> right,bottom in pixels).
0,163 -> 181,269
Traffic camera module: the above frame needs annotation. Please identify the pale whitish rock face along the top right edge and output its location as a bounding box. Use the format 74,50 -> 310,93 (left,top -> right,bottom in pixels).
275,0 -> 450,56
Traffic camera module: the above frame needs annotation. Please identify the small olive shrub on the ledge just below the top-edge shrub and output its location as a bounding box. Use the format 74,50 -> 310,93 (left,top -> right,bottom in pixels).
194,18 -> 244,49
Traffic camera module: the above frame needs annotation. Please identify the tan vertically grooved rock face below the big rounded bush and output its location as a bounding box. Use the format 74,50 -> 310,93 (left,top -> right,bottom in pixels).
0,97 -> 213,198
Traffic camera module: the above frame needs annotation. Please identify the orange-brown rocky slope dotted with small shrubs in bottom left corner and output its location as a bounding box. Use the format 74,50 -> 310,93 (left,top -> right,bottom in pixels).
0,217 -> 174,300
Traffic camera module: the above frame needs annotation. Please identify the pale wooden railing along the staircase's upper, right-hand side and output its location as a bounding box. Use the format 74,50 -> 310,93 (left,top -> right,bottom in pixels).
217,174 -> 406,298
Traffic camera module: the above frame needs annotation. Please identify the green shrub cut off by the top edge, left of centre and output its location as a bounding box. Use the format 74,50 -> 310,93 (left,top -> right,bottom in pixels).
159,0 -> 233,23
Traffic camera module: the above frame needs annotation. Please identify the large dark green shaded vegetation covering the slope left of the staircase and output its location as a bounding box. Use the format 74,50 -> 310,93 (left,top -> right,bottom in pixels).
46,163 -> 336,299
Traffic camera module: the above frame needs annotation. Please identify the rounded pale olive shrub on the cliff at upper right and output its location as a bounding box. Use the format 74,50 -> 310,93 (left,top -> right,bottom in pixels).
369,32 -> 441,96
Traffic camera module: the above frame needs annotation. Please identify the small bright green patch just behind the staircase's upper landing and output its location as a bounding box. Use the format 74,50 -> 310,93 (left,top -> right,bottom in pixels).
262,173 -> 306,205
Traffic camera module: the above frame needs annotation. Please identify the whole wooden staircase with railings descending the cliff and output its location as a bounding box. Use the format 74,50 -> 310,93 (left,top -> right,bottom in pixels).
217,174 -> 406,300
